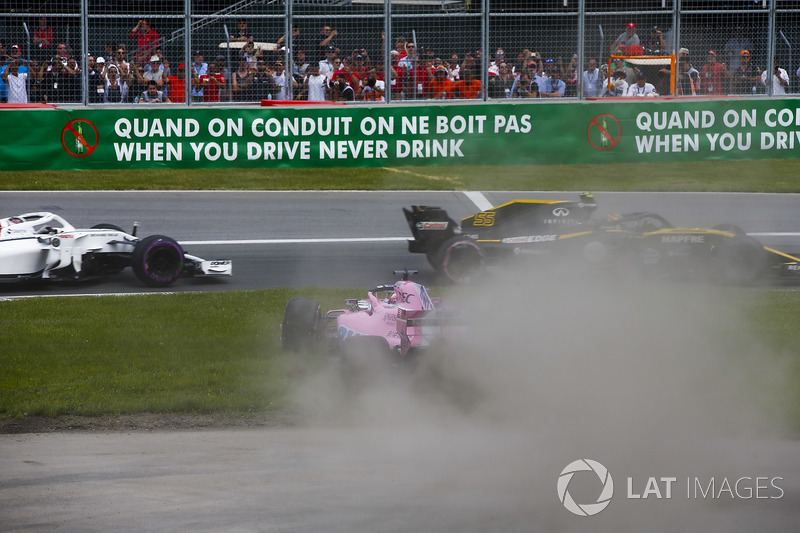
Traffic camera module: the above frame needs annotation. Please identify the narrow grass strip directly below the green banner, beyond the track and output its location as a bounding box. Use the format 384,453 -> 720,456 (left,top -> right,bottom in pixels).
0,159 -> 800,193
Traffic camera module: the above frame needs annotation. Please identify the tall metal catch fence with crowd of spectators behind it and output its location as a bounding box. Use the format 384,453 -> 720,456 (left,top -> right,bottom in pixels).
0,0 -> 800,106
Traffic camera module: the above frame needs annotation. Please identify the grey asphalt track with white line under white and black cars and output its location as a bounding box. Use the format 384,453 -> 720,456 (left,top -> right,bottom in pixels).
0,191 -> 800,297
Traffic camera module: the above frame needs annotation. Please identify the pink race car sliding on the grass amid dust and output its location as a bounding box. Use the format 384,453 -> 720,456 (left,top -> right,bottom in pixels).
281,270 -> 452,356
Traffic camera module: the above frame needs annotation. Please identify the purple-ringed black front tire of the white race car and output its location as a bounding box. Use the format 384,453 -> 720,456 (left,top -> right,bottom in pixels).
131,235 -> 184,287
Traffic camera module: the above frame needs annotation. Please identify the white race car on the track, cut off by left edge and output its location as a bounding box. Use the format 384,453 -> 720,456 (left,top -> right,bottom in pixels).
0,212 -> 233,287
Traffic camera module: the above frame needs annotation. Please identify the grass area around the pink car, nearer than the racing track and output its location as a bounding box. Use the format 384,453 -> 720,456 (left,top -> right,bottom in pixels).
0,289 -> 800,429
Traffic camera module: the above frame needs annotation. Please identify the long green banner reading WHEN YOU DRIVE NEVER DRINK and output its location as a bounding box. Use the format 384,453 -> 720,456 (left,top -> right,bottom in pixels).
0,98 -> 800,170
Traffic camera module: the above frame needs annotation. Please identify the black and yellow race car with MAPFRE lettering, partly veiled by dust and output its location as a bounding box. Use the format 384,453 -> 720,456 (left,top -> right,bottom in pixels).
403,194 -> 800,284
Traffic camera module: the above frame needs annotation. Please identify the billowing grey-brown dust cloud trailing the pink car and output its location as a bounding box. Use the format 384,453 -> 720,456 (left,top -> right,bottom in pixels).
284,271 -> 797,532
